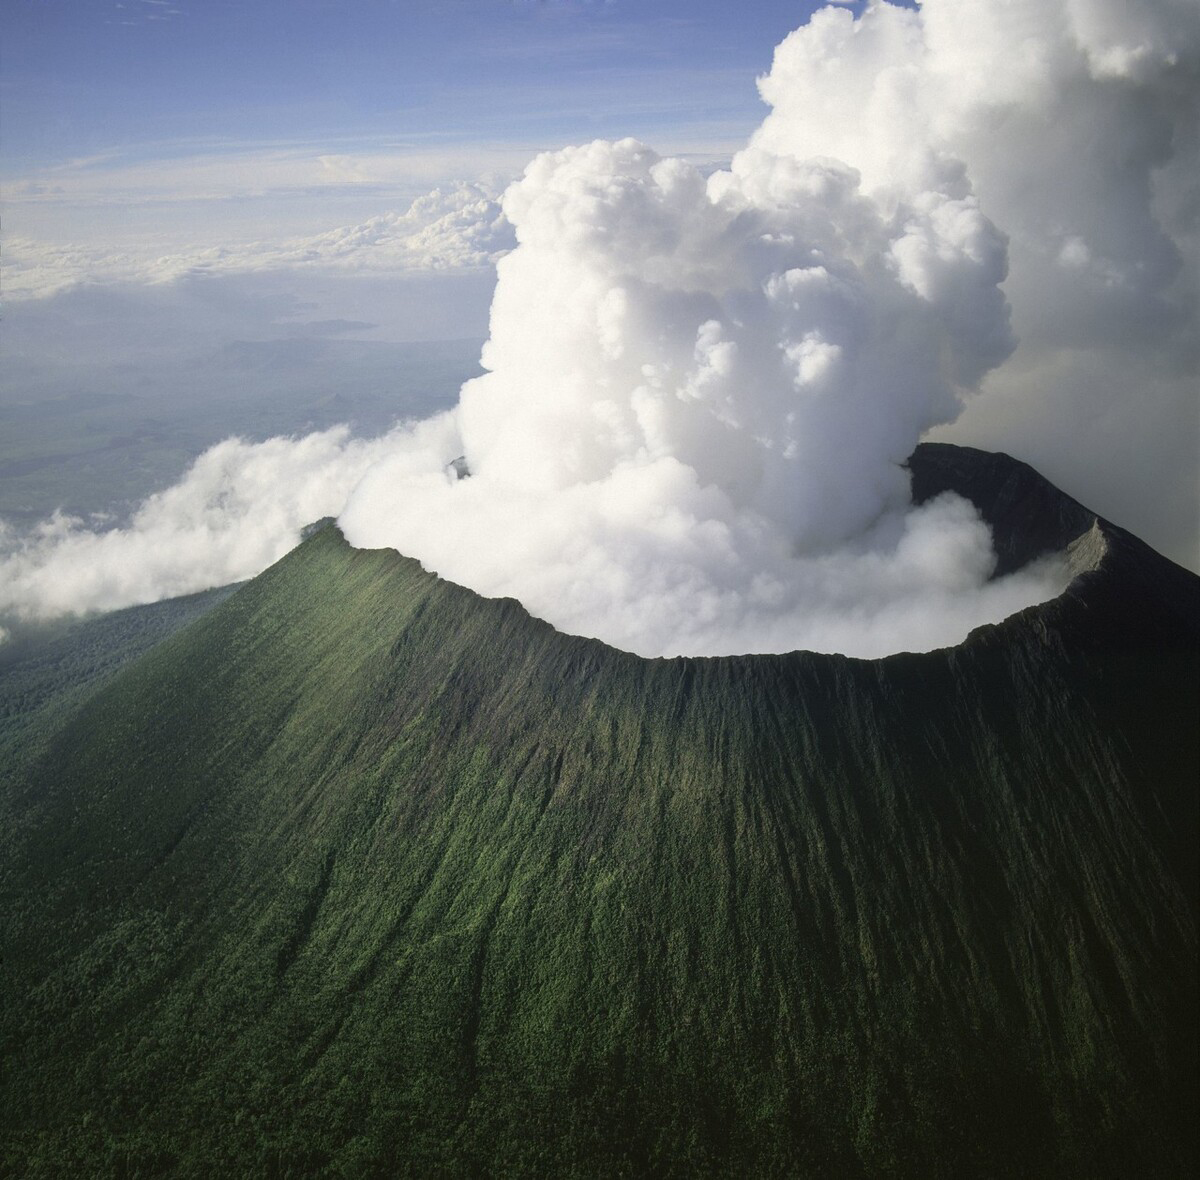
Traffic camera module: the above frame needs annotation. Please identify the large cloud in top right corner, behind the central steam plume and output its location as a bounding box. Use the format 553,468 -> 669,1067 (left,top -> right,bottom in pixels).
753,0 -> 1200,357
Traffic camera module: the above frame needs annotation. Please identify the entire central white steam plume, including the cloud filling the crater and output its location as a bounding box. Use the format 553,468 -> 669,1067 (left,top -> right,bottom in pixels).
341,122 -> 1062,655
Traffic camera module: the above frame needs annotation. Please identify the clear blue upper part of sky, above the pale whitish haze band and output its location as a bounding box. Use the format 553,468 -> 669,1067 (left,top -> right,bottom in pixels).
4,0 -> 854,164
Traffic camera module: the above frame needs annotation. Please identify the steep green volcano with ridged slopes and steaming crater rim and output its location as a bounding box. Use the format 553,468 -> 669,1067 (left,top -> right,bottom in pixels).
0,444 -> 1200,1176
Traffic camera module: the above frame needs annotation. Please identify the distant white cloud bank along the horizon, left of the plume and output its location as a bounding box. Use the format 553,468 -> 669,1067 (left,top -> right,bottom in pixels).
4,184 -> 514,300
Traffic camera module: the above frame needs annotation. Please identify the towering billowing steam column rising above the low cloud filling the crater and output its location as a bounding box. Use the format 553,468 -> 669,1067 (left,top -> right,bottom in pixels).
460,133 -> 1009,549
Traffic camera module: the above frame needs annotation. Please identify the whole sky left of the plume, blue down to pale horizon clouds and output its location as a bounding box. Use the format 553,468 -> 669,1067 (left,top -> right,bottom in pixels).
0,0 -> 873,241
